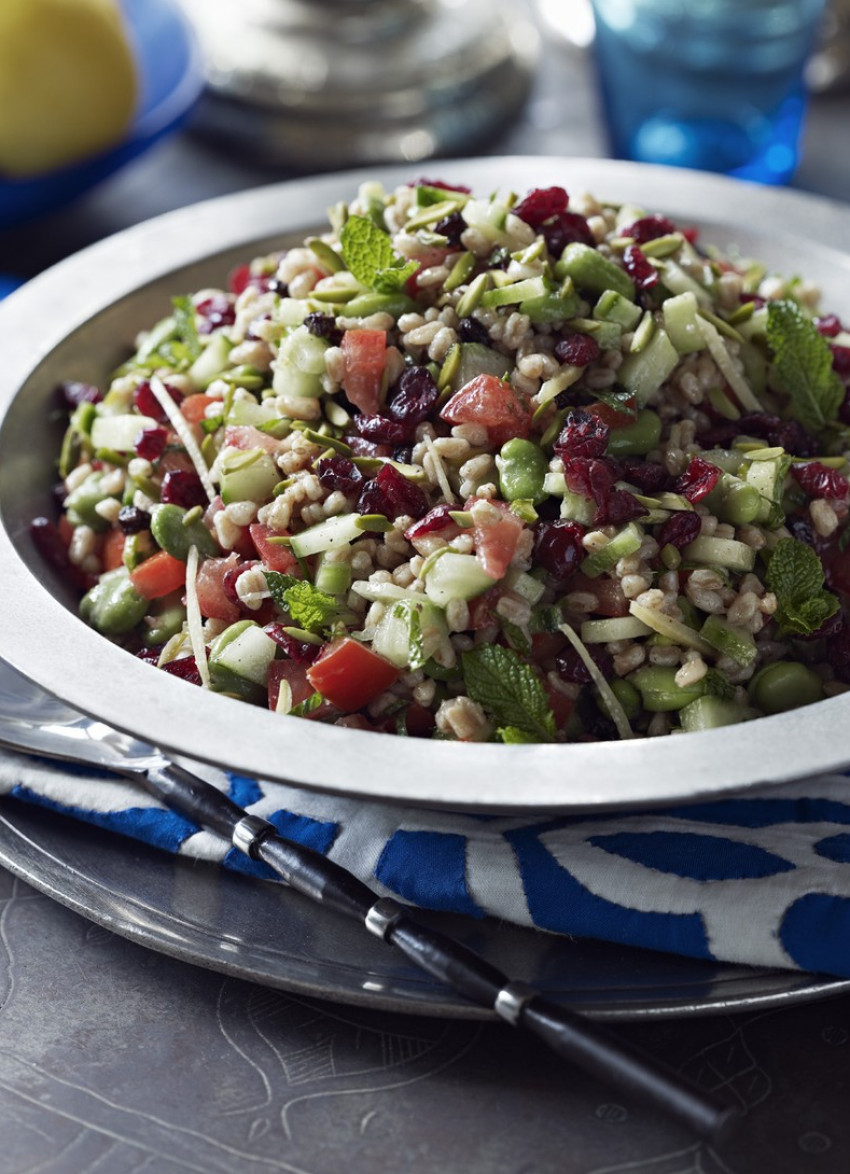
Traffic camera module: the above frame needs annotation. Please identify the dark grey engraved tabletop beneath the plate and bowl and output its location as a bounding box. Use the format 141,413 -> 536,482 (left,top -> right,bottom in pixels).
0,13 -> 850,1174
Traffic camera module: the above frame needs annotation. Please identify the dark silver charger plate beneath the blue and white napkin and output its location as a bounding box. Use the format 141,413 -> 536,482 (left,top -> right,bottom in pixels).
0,799 -> 850,1020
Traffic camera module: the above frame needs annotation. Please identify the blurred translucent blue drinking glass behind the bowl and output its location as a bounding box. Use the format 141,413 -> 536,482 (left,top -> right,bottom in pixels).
593,0 -> 824,183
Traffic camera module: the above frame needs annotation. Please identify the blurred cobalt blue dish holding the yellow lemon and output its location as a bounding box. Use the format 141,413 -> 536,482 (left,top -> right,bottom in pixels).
0,0 -> 203,231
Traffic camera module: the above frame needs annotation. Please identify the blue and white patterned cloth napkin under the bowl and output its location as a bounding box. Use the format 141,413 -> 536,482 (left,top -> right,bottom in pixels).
0,754 -> 850,978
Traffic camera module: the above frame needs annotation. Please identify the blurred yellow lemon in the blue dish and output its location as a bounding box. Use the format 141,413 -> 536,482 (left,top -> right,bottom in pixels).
0,0 -> 137,177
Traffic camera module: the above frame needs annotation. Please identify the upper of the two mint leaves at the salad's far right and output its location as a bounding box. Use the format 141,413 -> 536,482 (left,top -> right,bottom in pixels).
768,301 -> 844,432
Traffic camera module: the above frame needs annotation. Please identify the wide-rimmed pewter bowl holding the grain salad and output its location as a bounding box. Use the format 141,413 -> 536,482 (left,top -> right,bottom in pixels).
0,157 -> 850,811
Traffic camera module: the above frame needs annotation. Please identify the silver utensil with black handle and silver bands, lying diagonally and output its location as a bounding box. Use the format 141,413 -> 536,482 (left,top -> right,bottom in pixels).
0,662 -> 738,1143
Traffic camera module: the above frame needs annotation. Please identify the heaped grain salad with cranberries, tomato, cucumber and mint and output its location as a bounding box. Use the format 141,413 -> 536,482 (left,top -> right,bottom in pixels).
33,180 -> 850,742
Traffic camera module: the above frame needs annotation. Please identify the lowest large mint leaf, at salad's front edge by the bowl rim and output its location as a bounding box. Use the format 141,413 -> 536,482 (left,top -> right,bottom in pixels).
463,645 -> 555,742
